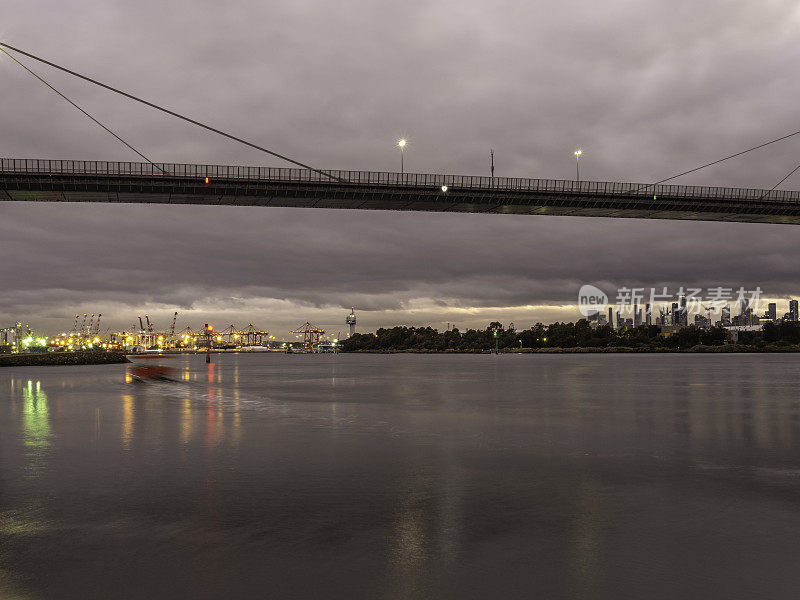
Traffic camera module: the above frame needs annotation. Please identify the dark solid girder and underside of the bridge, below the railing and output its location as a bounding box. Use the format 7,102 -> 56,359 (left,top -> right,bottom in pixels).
0,172 -> 800,225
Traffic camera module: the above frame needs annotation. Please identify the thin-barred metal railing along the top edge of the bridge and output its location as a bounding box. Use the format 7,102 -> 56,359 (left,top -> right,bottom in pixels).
0,158 -> 800,202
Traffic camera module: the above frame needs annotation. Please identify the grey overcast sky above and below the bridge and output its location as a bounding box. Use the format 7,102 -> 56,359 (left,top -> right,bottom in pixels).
0,0 -> 800,337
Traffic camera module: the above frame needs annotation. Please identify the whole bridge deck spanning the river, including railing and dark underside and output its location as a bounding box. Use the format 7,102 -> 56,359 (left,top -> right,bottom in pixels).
0,159 -> 800,224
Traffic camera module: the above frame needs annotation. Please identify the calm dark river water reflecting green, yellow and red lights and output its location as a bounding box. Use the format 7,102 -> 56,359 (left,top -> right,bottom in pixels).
0,354 -> 800,600
